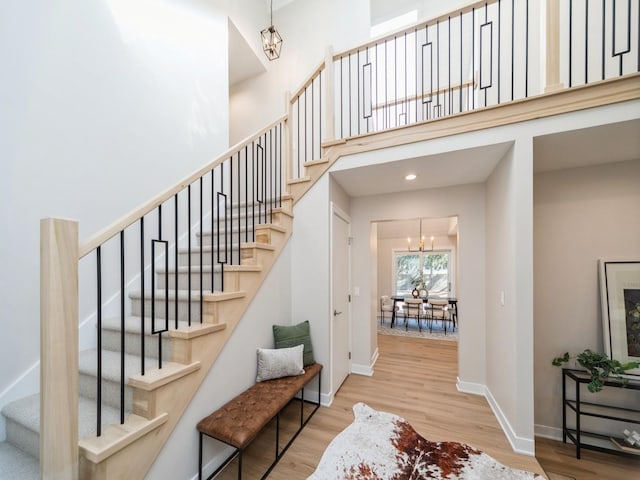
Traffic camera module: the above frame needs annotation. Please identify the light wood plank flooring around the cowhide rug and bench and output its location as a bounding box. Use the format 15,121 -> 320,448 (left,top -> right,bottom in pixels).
212,335 -> 640,480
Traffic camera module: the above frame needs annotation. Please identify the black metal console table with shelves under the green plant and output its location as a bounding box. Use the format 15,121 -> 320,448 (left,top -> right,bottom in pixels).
562,368 -> 640,458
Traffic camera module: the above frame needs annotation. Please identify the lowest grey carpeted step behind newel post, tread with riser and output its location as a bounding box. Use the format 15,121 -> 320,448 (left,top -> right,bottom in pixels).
0,393 -> 120,465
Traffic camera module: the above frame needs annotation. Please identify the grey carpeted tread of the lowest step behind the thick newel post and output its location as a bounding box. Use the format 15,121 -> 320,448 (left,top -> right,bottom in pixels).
0,393 -> 120,440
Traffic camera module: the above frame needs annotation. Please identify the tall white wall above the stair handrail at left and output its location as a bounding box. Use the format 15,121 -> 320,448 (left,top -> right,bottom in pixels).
0,0 -> 235,416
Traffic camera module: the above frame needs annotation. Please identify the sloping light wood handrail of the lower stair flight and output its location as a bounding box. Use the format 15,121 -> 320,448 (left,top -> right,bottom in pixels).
78,115 -> 287,259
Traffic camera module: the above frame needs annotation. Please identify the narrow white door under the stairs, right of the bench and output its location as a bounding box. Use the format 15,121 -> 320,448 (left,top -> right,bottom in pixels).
331,205 -> 351,395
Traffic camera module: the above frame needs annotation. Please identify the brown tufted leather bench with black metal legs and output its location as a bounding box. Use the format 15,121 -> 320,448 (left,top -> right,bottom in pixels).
197,363 -> 322,479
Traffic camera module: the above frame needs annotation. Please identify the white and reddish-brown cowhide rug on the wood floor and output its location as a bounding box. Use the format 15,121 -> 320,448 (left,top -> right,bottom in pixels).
309,403 -> 543,480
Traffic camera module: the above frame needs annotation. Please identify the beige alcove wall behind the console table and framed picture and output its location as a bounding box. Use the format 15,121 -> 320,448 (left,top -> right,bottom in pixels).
534,159 -> 640,438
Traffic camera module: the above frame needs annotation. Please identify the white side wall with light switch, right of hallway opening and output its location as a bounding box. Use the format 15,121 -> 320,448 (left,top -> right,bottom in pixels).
486,138 -> 534,452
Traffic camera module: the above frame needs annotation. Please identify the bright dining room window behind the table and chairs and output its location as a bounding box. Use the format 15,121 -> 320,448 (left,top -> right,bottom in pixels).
394,251 -> 451,296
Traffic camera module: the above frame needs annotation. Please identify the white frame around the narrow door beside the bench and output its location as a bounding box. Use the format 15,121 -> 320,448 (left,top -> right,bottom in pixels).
329,202 -> 352,404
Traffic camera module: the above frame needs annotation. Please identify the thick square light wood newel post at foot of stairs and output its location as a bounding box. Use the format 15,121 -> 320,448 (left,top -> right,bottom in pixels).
40,218 -> 78,480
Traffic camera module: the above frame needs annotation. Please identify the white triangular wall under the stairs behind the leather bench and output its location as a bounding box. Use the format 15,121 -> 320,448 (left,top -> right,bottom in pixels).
145,242 -> 292,480
